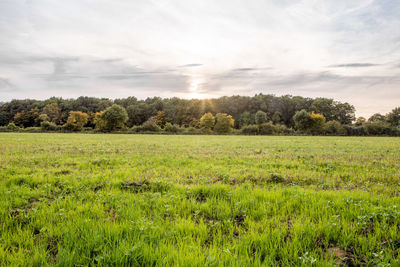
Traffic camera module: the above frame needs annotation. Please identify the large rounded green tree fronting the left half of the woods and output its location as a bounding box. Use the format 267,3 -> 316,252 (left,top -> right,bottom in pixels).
96,104 -> 128,131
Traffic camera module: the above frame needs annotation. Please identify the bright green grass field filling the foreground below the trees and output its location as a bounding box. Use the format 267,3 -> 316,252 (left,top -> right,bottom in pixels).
0,133 -> 400,266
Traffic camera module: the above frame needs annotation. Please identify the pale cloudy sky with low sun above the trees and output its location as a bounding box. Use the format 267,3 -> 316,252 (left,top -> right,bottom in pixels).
0,0 -> 400,117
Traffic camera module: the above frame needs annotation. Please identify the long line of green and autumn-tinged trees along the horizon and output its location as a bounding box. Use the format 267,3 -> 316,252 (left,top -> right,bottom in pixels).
0,94 -> 400,135
